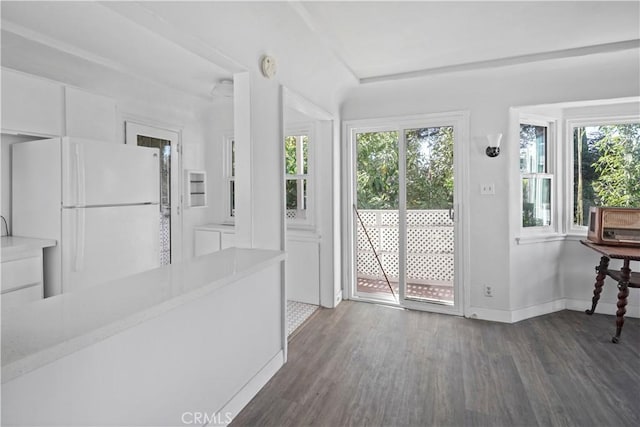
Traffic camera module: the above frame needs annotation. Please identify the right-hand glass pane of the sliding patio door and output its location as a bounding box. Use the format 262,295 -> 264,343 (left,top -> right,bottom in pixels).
404,126 -> 454,305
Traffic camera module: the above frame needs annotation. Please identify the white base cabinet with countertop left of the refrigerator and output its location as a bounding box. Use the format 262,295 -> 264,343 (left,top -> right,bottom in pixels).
2,236 -> 55,310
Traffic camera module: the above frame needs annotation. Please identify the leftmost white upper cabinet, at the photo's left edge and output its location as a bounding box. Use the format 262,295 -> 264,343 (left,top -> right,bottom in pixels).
2,68 -> 63,136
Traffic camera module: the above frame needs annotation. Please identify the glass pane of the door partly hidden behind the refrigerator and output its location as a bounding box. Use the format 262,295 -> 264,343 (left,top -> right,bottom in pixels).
137,135 -> 171,265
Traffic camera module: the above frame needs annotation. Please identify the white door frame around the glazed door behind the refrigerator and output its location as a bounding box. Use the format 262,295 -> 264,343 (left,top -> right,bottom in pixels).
125,120 -> 183,264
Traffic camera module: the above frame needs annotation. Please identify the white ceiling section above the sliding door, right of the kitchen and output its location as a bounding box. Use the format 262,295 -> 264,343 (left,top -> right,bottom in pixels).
299,1 -> 640,79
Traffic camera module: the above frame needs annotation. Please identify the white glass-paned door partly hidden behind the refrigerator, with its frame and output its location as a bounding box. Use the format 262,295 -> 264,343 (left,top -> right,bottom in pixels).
125,121 -> 182,265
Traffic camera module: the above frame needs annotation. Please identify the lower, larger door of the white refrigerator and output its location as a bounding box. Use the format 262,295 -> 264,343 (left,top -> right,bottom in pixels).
61,205 -> 160,292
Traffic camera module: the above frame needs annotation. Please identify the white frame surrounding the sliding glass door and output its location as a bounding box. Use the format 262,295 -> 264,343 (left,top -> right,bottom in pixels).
342,111 -> 470,315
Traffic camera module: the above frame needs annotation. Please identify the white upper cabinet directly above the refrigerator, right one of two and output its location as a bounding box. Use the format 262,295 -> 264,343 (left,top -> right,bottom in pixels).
65,87 -> 116,142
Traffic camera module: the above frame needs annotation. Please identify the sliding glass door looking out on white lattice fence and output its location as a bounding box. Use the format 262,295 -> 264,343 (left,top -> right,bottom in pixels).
352,120 -> 459,311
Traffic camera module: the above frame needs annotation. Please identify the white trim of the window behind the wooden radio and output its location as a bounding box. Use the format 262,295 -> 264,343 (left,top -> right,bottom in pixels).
564,114 -> 640,238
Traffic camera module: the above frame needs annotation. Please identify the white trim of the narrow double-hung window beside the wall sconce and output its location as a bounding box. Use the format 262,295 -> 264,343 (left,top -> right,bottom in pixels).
516,114 -> 561,237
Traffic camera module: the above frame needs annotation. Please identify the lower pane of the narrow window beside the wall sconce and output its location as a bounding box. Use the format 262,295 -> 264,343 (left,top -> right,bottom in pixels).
522,178 -> 551,227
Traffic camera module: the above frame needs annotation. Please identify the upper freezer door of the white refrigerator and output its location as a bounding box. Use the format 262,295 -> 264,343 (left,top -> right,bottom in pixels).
62,138 -> 159,206
